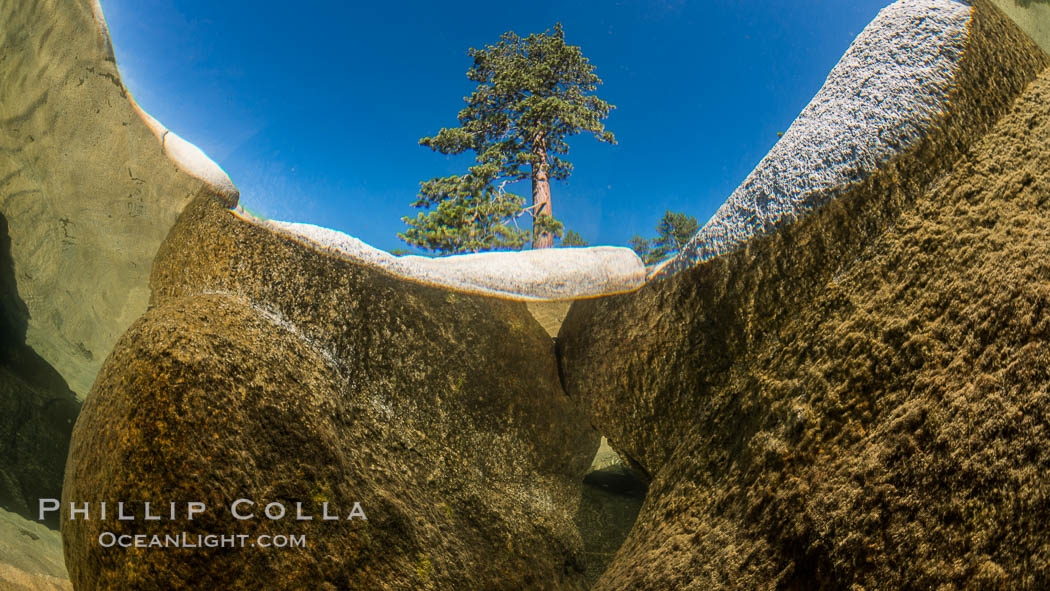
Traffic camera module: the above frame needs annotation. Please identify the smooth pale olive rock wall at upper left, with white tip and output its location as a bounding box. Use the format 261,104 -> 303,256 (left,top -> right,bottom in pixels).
0,0 -> 236,397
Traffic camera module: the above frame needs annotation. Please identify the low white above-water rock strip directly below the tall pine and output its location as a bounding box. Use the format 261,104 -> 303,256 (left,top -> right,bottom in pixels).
264,220 -> 646,300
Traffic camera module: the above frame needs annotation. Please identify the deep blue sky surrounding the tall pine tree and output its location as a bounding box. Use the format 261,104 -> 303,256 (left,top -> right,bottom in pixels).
102,0 -> 888,250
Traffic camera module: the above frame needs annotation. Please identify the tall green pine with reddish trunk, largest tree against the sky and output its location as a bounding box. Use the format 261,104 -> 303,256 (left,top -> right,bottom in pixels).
399,23 -> 616,252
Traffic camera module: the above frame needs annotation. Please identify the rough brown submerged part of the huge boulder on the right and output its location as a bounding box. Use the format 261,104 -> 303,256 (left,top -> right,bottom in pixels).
558,1 -> 1050,591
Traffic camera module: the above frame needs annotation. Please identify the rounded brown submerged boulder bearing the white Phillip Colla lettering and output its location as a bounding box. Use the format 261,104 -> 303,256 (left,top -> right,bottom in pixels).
63,193 -> 599,590
